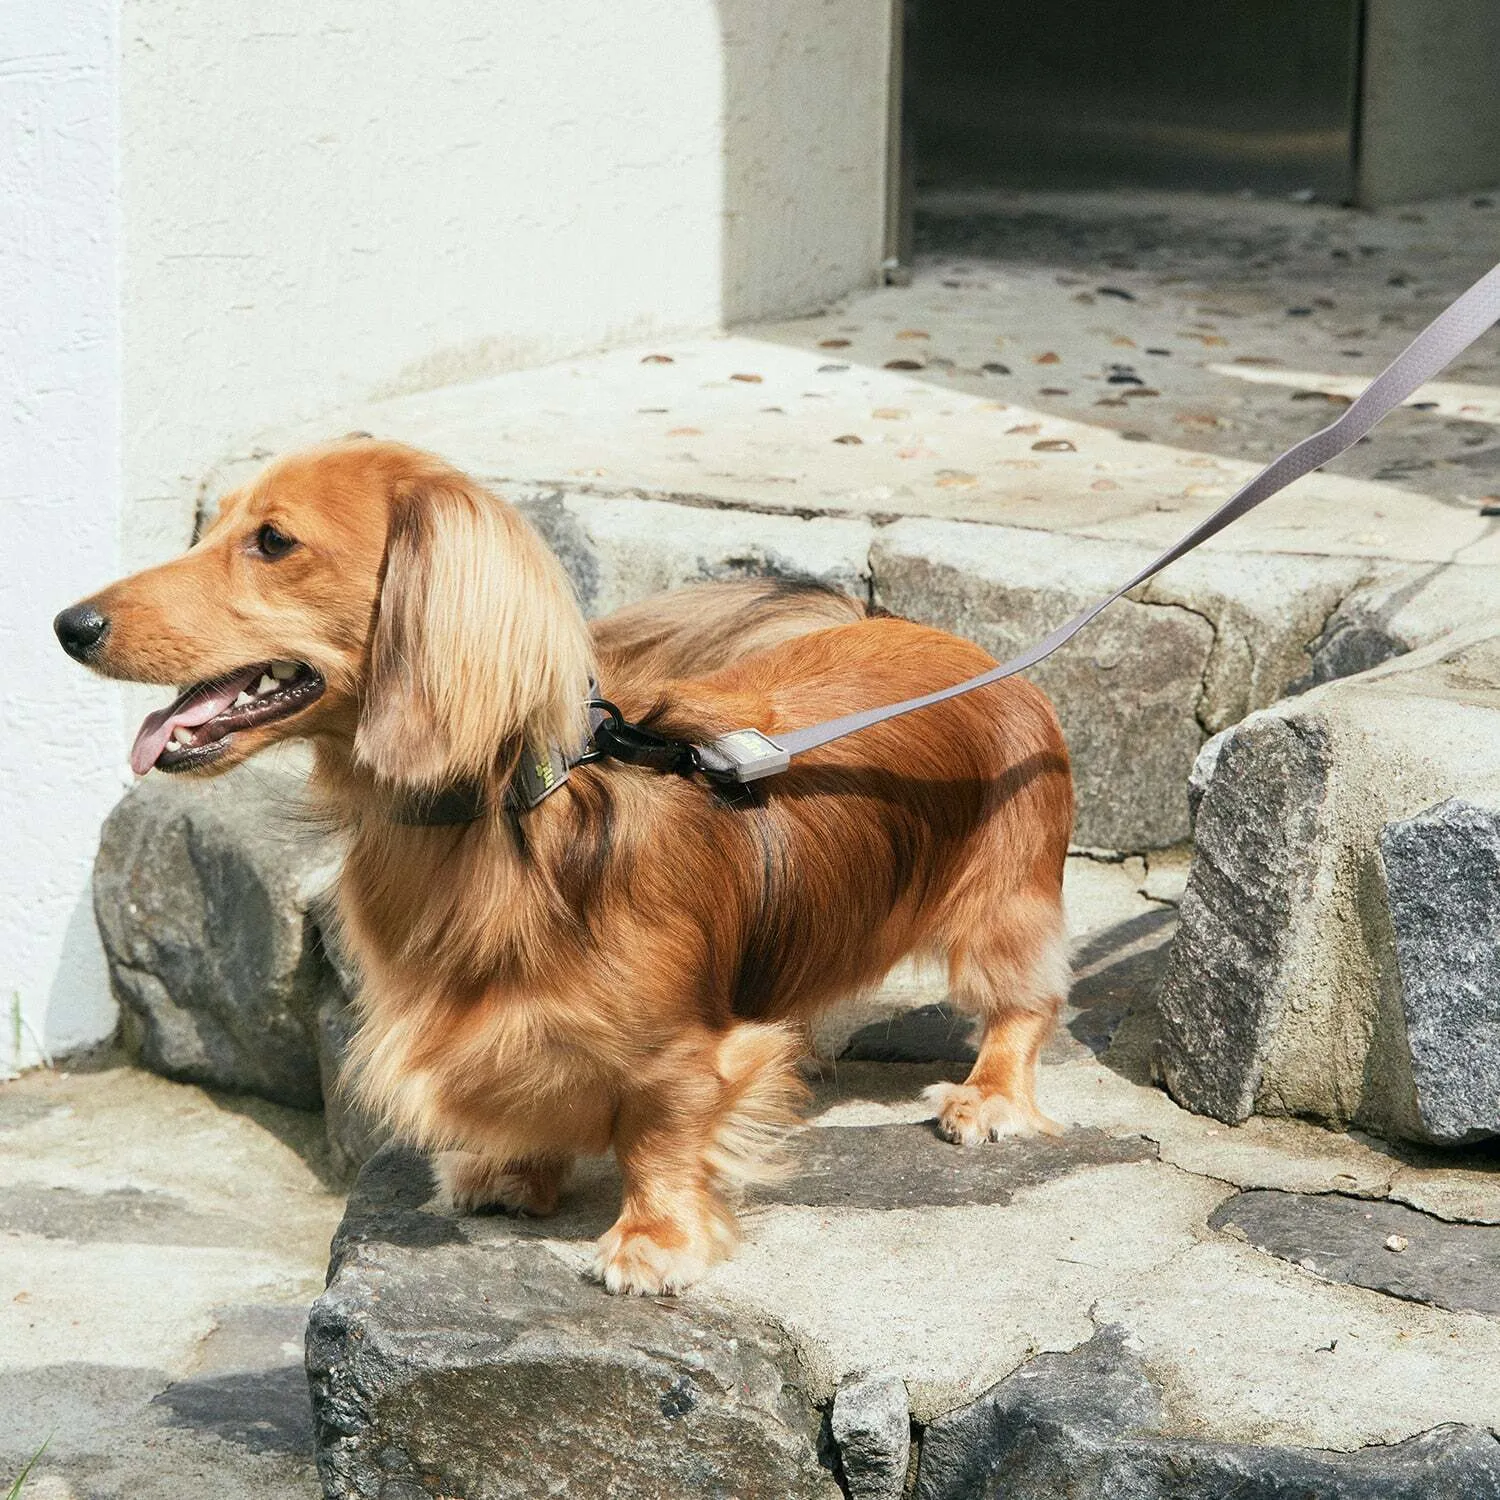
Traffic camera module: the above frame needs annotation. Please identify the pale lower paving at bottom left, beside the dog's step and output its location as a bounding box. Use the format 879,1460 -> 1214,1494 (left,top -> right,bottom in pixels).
0,1067 -> 342,1500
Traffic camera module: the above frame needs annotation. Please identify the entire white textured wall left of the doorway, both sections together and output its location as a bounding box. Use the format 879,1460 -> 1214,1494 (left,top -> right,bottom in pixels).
0,0 -> 893,1067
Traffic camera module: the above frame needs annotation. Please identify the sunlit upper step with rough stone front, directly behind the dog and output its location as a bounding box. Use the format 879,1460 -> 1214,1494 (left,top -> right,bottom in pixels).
207,318 -> 1500,851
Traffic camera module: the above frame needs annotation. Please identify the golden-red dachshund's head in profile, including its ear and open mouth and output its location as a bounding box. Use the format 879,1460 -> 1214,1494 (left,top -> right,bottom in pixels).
54,441 -> 590,789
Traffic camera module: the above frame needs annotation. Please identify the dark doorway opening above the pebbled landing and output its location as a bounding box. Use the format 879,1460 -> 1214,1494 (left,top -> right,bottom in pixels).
906,0 -> 1361,201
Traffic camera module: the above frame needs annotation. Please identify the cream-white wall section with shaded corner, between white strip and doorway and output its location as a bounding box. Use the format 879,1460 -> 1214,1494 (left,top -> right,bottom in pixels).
123,0 -> 891,563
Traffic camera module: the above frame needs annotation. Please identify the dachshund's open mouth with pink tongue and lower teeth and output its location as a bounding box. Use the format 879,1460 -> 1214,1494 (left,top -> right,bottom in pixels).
131,662 -> 326,776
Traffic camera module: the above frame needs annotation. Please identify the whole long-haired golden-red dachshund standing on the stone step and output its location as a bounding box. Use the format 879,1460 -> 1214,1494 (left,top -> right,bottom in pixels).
56,441 -> 1073,1293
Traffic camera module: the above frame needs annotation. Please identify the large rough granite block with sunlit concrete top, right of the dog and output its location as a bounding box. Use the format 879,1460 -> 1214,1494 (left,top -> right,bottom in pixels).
1160,627 -> 1500,1146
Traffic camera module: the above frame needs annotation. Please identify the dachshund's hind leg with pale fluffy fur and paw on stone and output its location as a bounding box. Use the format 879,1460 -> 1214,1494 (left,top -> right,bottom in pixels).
926,896 -> 1068,1146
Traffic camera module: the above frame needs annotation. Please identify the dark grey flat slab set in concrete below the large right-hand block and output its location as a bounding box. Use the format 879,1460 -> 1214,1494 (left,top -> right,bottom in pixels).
1209,1191 -> 1500,1317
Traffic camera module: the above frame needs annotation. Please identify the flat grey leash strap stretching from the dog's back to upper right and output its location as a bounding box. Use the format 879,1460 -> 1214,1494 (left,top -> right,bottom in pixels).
698,266 -> 1500,782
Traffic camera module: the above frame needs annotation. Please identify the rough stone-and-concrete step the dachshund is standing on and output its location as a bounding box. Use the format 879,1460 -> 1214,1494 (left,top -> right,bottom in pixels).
308,1050 -> 1500,1500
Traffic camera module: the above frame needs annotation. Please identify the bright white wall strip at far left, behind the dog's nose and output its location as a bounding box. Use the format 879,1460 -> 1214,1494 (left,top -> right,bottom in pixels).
0,0 -> 123,1073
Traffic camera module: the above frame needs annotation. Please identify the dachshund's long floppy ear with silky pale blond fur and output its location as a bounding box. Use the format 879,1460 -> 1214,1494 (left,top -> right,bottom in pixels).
354,471 -> 593,788
